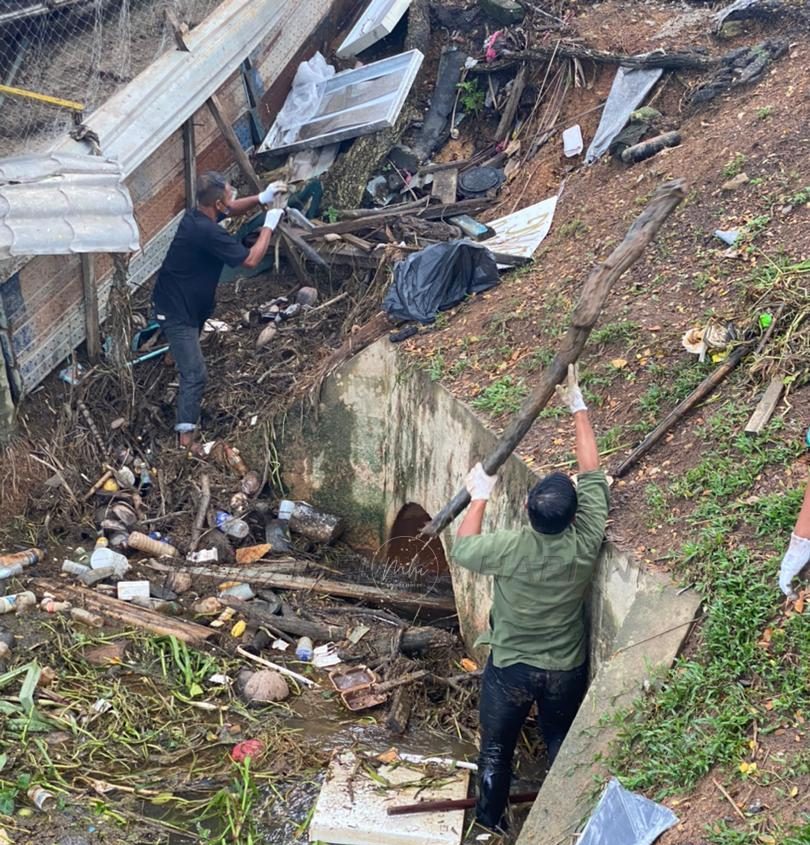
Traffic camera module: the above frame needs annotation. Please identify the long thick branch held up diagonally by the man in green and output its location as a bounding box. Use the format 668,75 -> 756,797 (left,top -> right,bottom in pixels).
422,179 -> 686,536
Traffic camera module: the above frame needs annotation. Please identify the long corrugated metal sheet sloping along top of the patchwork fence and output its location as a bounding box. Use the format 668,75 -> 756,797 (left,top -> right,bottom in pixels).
54,0 -> 332,176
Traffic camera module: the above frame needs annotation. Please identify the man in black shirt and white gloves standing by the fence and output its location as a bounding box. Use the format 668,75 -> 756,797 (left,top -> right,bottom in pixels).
152,171 -> 286,448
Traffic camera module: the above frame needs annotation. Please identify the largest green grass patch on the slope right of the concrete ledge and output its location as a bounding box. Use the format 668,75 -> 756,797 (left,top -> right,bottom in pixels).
611,416 -> 810,796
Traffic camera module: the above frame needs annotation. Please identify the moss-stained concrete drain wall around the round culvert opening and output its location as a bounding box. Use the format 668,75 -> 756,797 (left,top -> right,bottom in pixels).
282,338 -> 699,845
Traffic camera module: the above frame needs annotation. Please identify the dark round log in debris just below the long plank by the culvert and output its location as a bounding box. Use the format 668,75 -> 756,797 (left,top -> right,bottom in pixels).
220,596 -> 456,654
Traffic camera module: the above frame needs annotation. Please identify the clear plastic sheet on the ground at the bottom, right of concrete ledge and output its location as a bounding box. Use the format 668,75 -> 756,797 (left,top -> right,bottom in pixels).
578,778 -> 678,845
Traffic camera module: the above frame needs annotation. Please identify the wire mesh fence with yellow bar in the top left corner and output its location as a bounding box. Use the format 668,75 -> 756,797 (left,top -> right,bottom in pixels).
0,0 -> 222,156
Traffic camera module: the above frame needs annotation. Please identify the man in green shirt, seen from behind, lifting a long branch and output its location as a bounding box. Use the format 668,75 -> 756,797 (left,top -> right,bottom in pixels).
453,367 -> 609,829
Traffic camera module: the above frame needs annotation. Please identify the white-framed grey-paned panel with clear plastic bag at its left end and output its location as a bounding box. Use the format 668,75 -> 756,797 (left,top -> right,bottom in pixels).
259,50 -> 424,153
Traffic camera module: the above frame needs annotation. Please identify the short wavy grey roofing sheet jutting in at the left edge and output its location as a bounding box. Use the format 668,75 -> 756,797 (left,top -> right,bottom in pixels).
0,153 -> 139,258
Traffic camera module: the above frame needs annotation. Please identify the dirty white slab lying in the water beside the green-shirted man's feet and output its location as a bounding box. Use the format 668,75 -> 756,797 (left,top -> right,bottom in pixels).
309,751 -> 469,845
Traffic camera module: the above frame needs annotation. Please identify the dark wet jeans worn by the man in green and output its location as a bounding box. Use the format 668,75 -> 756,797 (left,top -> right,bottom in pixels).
476,657 -> 588,829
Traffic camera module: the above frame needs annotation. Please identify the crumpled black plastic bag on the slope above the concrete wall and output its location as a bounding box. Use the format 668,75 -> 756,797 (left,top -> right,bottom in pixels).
383,241 -> 498,323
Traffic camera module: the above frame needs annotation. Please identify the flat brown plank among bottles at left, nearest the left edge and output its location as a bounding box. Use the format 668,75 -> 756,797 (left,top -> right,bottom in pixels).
32,567 -> 216,645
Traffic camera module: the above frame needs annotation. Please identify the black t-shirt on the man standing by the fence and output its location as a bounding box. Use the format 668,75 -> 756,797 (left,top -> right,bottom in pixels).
152,208 -> 249,328
